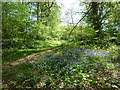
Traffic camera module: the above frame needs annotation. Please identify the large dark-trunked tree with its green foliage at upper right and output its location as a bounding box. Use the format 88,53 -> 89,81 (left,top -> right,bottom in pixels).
86,2 -> 120,45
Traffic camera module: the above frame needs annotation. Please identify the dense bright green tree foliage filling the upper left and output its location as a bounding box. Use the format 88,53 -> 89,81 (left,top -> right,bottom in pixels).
2,2 -> 60,49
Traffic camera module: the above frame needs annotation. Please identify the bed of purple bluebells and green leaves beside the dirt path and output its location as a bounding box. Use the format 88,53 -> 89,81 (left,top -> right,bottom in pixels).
4,47 -> 119,89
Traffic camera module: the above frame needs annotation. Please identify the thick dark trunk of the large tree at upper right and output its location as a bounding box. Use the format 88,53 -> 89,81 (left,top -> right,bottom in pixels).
87,2 -> 103,37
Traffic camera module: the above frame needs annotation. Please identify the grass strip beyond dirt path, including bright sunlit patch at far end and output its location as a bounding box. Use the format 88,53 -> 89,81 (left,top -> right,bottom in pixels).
2,41 -> 64,63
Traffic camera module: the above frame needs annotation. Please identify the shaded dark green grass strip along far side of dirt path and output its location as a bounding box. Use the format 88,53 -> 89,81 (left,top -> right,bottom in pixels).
2,45 -> 61,64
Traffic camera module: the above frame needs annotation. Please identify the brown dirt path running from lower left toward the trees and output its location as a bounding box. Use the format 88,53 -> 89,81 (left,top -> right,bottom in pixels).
2,47 -> 57,87
